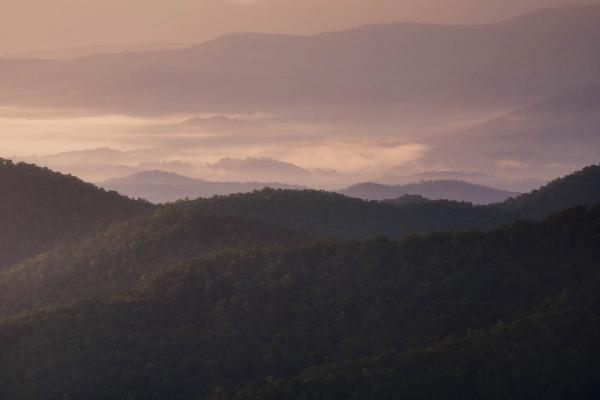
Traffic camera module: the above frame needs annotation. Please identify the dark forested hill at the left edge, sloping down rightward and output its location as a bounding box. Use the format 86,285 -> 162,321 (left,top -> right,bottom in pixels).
0,159 -> 150,269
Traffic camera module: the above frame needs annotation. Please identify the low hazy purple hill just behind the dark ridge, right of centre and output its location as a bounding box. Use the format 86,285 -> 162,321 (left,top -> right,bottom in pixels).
340,180 -> 518,204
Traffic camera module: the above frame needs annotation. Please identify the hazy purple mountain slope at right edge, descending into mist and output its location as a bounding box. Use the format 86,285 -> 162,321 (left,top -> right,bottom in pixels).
432,84 -> 600,173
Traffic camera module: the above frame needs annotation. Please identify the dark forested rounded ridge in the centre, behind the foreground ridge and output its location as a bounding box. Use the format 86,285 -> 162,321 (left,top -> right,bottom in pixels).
189,189 -> 516,238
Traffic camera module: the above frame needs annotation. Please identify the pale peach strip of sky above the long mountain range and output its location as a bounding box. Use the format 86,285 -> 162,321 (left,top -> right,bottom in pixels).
0,0 -> 593,56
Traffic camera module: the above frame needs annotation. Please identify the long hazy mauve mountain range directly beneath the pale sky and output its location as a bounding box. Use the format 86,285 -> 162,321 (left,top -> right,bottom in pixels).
0,5 -> 600,113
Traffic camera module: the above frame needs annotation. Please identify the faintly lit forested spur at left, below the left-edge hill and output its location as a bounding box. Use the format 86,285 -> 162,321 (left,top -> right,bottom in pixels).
0,202 -> 306,317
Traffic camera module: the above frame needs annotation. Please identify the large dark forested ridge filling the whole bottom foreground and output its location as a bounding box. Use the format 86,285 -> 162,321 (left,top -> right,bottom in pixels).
0,207 -> 600,400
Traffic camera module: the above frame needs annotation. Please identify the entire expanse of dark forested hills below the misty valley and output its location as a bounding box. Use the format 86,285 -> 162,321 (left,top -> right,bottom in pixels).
0,161 -> 600,400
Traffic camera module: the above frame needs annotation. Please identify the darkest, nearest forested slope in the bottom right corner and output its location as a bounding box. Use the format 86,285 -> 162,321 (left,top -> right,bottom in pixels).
241,304 -> 600,400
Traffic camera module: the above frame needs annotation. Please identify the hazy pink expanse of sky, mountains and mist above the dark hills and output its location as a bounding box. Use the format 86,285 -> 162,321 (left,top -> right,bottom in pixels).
0,0 -> 600,189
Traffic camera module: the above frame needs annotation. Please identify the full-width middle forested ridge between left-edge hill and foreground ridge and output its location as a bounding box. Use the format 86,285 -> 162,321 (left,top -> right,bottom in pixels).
0,167 -> 600,317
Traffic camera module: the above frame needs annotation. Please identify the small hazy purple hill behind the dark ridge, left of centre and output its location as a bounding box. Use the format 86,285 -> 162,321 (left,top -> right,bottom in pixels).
100,171 -> 304,203
